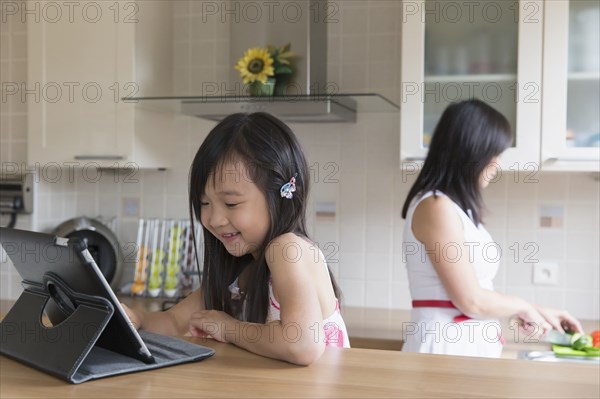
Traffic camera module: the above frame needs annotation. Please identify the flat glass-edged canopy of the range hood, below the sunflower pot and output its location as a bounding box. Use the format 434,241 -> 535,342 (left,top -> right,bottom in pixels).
122,93 -> 400,123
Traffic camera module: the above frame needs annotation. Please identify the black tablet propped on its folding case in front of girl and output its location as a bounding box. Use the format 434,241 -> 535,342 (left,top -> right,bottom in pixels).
0,228 -> 155,363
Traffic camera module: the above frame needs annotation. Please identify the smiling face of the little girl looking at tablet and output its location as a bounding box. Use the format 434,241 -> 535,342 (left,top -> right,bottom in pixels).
200,161 -> 270,257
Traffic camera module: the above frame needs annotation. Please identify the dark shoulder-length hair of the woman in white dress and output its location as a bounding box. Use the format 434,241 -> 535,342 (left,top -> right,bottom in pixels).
402,100 -> 512,225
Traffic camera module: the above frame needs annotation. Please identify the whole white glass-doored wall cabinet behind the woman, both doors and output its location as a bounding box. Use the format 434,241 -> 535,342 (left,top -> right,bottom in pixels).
400,0 -> 600,171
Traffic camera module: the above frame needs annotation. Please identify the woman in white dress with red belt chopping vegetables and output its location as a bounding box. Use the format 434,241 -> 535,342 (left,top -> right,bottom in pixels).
402,100 -> 581,357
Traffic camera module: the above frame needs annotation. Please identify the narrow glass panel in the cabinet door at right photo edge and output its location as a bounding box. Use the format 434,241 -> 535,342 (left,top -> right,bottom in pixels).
565,0 -> 600,147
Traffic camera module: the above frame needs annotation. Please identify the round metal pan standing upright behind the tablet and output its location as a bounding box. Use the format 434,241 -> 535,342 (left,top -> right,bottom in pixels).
53,216 -> 123,288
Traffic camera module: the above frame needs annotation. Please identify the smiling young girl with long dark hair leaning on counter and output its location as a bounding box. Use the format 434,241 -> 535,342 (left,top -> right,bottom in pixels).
128,112 -> 350,365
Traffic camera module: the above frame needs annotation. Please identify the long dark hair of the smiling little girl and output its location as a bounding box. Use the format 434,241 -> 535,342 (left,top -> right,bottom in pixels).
189,112 -> 338,323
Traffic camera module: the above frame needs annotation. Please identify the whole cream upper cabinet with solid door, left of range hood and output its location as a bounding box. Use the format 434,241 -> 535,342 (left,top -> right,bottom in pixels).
27,1 -> 173,168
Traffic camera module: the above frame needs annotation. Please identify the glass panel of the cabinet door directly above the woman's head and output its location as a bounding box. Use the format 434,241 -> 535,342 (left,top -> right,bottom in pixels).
422,0 -> 519,148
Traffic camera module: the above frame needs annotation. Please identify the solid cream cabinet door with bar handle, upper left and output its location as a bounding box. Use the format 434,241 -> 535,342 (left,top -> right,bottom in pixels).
28,2 -> 135,166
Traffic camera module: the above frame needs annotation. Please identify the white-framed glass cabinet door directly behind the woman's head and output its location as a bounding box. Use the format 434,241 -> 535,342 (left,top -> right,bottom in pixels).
400,0 -> 543,170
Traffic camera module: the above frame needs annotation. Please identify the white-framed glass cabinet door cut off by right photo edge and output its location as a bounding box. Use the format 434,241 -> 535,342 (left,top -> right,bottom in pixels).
542,0 -> 600,171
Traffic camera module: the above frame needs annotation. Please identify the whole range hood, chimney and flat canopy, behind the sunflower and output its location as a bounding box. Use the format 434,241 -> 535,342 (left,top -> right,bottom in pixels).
129,0 -> 399,123
